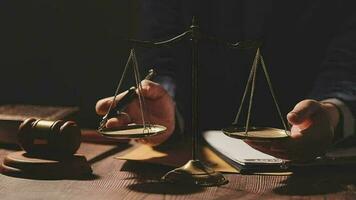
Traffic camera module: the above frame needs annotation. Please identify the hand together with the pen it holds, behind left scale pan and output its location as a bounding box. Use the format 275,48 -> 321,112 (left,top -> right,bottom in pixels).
96,69 -> 175,146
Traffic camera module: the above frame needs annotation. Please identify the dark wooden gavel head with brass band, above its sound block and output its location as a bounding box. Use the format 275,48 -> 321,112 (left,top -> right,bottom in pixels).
18,118 -> 81,156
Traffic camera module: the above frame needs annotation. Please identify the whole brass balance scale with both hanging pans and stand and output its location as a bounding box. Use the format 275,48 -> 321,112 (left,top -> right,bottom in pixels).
98,17 -> 290,186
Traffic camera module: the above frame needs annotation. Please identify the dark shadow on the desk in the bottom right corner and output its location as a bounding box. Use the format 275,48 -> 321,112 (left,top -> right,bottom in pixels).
274,166 -> 356,195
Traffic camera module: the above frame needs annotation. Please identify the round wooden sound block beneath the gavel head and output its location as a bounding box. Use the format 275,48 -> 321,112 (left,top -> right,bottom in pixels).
1,151 -> 92,179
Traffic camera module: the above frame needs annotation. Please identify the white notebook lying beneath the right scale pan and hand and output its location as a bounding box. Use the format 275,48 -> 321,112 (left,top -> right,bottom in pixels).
203,130 -> 356,172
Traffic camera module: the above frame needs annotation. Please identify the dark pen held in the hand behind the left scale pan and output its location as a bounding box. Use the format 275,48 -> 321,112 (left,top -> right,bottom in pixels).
98,69 -> 156,131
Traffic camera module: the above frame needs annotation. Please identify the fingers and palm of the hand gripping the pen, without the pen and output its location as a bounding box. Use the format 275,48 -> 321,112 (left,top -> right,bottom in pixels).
96,80 -> 175,146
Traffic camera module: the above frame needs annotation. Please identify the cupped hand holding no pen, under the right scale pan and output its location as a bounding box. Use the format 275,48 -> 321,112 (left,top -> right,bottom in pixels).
245,100 -> 339,161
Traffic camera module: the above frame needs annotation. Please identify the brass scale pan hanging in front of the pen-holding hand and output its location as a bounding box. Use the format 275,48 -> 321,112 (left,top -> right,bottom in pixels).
99,124 -> 167,139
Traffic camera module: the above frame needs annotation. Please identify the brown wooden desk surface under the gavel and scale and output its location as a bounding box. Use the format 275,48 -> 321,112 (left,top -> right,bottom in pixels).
0,130 -> 356,200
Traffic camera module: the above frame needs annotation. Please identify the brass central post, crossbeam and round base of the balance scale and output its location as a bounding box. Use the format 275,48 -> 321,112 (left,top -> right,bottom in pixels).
125,17 -> 260,186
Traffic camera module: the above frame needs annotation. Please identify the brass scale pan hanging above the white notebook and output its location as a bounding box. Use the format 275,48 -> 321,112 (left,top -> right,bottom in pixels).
222,126 -> 290,140
